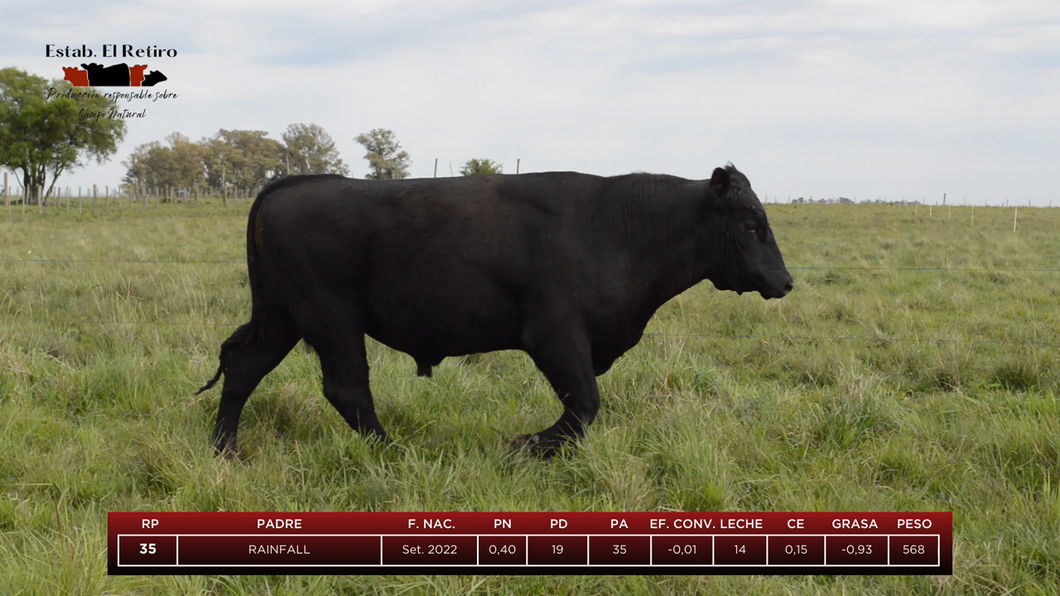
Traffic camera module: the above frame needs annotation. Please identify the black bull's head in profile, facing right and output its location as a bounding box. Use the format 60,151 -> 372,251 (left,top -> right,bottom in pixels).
704,163 -> 792,299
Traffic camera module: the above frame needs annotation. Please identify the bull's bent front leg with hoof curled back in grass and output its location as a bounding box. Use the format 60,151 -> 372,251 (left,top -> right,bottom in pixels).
515,326 -> 600,457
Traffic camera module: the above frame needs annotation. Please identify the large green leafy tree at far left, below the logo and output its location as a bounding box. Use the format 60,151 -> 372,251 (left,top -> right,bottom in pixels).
0,68 -> 125,203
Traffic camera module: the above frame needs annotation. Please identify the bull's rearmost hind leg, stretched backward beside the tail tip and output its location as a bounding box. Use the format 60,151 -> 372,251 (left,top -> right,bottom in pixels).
213,314 -> 299,457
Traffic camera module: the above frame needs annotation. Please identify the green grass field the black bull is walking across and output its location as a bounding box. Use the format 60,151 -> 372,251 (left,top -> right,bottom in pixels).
0,197 -> 1060,596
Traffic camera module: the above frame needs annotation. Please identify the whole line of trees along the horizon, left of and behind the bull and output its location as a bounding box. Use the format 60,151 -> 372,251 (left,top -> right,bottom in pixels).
0,68 -> 504,204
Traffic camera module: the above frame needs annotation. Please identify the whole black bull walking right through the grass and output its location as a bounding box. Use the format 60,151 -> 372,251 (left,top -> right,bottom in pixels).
199,164 -> 792,456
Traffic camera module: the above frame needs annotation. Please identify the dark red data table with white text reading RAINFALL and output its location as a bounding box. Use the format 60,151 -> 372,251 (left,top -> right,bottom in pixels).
107,512 -> 953,575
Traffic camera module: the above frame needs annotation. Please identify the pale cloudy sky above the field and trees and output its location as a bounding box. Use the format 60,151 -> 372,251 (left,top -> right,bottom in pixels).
0,0 -> 1060,206
